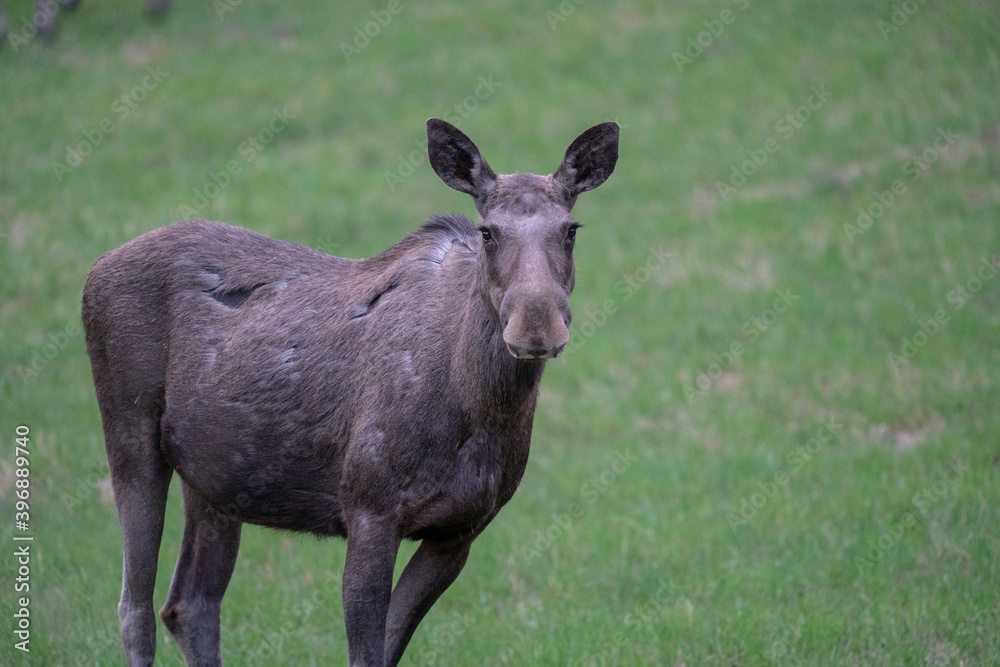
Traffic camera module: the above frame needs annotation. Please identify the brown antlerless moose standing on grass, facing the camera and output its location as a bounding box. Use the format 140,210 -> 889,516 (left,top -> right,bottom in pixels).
82,118 -> 619,666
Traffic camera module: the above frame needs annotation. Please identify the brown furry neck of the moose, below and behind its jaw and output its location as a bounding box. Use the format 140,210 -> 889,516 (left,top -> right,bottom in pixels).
452,283 -> 545,426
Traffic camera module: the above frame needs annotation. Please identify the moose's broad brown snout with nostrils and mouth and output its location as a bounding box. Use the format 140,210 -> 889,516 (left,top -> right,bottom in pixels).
501,295 -> 570,359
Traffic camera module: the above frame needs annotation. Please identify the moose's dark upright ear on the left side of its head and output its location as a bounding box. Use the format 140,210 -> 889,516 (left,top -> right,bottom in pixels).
427,118 -> 497,214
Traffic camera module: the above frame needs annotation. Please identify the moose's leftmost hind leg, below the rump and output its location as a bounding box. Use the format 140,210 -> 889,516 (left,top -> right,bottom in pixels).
105,415 -> 173,667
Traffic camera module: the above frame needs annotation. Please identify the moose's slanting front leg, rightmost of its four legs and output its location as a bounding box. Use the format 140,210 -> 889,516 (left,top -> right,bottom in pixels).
385,540 -> 471,665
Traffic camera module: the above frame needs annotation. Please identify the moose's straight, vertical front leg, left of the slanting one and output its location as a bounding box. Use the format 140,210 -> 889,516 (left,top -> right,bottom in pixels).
344,514 -> 400,667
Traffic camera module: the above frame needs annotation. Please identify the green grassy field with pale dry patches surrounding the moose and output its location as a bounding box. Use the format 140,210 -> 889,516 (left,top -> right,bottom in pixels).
0,0 -> 1000,667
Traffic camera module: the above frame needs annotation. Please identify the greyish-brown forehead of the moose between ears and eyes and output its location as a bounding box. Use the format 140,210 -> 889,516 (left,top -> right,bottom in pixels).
485,174 -> 572,224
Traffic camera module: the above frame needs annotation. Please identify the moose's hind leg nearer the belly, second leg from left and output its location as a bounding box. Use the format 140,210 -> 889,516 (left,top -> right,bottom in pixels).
160,484 -> 243,667
